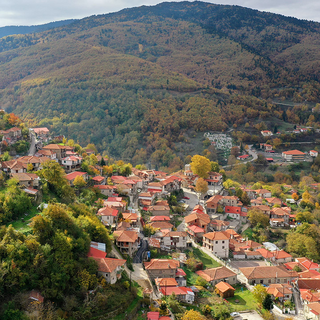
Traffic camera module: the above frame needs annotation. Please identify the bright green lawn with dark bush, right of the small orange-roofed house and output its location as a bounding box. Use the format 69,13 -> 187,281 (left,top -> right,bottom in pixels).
226,285 -> 258,311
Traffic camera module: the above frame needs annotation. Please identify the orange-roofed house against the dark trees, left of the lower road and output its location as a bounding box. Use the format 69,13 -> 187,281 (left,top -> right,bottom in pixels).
92,257 -> 126,284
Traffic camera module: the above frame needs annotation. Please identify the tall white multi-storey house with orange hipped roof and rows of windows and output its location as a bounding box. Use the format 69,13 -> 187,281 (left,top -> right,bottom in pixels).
203,231 -> 230,258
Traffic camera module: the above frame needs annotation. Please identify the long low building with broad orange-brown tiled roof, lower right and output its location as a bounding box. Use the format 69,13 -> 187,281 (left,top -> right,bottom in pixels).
239,266 -> 293,285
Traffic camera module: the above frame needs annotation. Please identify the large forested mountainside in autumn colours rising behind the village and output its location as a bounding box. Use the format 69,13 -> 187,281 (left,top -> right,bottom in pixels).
0,2 -> 320,166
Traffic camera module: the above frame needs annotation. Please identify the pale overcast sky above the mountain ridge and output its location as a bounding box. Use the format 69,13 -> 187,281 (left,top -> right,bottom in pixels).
0,0 -> 320,26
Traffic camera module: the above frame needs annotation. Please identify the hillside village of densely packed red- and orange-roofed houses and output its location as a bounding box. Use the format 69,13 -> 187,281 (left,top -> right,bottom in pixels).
1,119 -> 320,320
